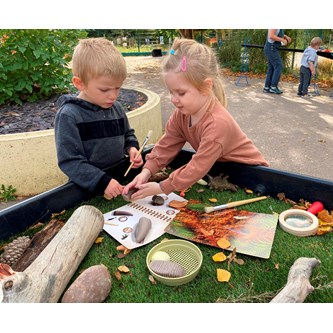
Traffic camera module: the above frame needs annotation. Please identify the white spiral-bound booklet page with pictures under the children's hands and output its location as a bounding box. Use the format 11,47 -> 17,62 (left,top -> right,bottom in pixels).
103,193 -> 187,249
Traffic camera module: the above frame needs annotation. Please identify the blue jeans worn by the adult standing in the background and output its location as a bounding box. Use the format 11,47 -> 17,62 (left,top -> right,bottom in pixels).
264,42 -> 283,87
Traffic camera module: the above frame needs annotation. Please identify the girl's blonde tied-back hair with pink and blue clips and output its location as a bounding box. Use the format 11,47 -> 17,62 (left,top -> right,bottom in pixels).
162,38 -> 227,106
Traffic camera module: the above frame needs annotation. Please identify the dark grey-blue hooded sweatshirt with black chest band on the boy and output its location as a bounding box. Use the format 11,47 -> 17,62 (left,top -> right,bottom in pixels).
54,95 -> 139,194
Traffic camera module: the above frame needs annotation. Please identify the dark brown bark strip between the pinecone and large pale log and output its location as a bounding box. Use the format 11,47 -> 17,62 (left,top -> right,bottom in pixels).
12,219 -> 64,272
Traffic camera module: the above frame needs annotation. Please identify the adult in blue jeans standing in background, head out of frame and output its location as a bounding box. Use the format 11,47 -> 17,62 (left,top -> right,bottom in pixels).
264,29 -> 291,95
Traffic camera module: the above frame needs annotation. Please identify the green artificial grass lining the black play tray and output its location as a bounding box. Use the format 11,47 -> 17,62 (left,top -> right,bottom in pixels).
50,185 -> 333,303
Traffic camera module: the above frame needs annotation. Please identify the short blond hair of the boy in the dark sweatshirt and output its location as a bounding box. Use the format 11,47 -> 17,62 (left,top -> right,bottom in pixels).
71,37 -> 127,84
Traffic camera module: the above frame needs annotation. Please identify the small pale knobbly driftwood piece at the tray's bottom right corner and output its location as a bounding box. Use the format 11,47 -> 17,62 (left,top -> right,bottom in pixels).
270,258 -> 320,303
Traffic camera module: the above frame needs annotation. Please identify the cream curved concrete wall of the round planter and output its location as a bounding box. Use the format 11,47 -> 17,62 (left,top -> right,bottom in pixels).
0,87 -> 163,196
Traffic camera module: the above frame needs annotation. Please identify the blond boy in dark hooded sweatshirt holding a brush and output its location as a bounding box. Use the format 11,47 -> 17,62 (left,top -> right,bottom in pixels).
55,38 -> 143,199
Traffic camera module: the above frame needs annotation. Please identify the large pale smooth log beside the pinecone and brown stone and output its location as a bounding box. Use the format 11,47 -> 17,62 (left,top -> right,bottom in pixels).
2,205 -> 104,303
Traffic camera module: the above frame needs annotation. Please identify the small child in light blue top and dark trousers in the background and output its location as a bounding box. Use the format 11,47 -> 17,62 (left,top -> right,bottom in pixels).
297,37 -> 322,97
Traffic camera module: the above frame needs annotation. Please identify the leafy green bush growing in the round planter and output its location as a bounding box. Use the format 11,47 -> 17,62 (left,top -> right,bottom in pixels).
0,29 -> 87,105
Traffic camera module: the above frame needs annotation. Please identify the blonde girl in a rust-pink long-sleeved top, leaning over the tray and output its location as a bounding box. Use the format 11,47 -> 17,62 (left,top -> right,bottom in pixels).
123,39 -> 268,200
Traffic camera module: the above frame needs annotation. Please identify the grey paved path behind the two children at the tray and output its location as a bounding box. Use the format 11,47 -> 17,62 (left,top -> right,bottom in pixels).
125,57 -> 333,181
